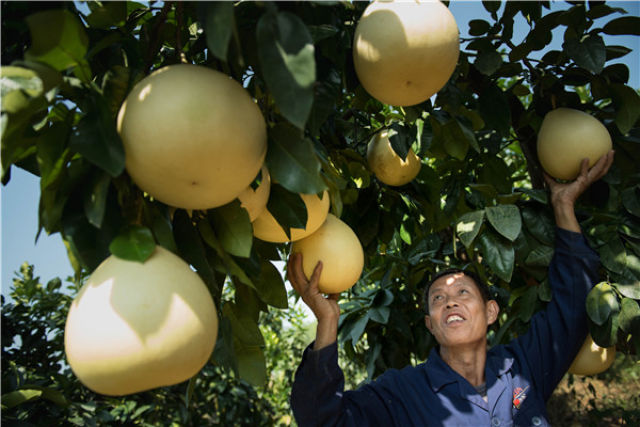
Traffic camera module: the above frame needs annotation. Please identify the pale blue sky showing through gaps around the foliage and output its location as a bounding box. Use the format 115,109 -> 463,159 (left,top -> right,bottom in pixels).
0,1 -> 640,295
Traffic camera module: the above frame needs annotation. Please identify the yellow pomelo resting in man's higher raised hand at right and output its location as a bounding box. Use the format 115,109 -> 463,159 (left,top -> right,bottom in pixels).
538,108 -> 612,180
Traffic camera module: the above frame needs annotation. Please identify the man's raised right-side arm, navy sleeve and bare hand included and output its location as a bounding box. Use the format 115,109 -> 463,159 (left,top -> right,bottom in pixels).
513,151 -> 613,401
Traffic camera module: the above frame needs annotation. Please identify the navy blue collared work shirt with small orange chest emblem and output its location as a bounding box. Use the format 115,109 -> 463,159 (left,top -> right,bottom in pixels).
291,228 -> 599,427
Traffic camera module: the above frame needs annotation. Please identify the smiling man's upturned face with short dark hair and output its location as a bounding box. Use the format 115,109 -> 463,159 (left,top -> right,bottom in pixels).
425,273 -> 498,347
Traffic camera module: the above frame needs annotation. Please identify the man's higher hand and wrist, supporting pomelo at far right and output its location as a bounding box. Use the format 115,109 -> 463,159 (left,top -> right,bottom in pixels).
544,150 -> 614,233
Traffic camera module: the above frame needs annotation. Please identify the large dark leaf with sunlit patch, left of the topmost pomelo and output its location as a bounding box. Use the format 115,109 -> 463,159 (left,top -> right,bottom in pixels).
257,12 -> 316,129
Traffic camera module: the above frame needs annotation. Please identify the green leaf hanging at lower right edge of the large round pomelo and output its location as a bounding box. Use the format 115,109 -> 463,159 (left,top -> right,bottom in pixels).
209,199 -> 253,258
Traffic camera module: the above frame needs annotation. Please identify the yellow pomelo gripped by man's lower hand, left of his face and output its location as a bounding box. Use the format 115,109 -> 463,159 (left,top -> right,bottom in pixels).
291,214 -> 364,294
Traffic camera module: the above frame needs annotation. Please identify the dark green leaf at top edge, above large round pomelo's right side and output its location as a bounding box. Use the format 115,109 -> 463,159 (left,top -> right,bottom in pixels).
199,1 -> 235,62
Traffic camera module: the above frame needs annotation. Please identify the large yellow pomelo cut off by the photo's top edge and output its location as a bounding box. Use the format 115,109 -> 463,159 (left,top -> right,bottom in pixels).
353,0 -> 460,106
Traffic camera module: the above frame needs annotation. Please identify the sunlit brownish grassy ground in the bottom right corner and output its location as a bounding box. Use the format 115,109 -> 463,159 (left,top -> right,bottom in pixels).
547,355 -> 640,427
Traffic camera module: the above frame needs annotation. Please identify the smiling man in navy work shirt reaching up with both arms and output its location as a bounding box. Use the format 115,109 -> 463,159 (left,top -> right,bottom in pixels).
287,151 -> 613,426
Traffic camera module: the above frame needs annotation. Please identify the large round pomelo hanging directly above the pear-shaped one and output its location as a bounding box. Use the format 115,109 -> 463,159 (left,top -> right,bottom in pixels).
117,64 -> 267,209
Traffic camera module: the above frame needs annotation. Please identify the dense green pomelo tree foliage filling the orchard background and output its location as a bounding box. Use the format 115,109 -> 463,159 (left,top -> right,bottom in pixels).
0,1 -> 640,425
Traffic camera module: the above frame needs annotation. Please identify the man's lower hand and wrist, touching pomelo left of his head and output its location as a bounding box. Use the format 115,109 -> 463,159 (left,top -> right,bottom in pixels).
287,253 -> 340,350
